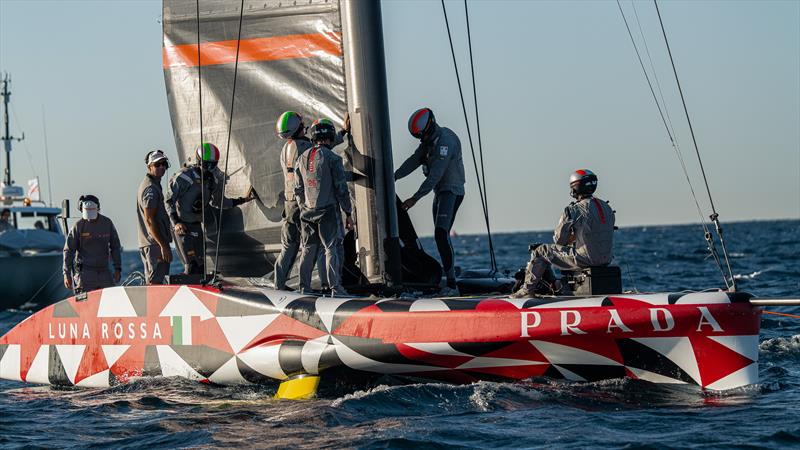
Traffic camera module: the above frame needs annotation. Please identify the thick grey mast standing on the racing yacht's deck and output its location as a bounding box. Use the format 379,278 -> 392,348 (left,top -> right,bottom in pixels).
341,0 -> 402,286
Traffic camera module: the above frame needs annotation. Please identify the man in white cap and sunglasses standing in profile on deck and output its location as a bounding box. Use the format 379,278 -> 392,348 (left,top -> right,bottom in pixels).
136,150 -> 172,284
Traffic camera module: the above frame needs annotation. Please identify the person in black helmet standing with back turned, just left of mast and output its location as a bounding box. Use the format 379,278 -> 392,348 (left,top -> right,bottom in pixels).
295,119 -> 353,295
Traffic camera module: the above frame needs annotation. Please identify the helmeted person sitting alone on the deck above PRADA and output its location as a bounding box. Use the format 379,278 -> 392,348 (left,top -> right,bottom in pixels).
512,169 -> 615,298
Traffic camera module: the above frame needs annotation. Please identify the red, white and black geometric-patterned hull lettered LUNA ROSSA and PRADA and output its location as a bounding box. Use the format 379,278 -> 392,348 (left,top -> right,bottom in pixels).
0,286 -> 761,390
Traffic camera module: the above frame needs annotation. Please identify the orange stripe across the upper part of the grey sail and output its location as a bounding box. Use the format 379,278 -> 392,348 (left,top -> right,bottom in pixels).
162,33 -> 342,69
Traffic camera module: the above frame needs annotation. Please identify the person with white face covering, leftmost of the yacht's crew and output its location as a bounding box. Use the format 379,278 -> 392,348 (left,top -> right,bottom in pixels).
64,195 -> 122,293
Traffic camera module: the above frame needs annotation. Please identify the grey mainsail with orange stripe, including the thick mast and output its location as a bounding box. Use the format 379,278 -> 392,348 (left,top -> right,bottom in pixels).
163,0 -> 399,284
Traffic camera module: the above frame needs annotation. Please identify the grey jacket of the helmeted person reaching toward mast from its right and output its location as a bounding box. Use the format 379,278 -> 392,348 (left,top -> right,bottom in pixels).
394,125 -> 465,200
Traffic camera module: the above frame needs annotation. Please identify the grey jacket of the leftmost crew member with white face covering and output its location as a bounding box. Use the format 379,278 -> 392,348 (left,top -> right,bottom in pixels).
64,214 -> 122,277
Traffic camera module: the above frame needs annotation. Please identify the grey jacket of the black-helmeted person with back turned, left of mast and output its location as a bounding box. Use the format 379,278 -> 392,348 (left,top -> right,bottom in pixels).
294,145 -> 353,215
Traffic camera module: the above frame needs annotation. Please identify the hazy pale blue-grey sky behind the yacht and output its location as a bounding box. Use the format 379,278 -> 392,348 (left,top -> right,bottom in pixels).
0,0 -> 800,249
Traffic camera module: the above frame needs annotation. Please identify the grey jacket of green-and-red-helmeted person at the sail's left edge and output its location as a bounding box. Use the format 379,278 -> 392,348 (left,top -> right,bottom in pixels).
164,166 -> 234,225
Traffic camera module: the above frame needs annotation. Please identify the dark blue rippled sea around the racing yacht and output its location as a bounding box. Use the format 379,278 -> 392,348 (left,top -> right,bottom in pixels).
0,220 -> 800,449
